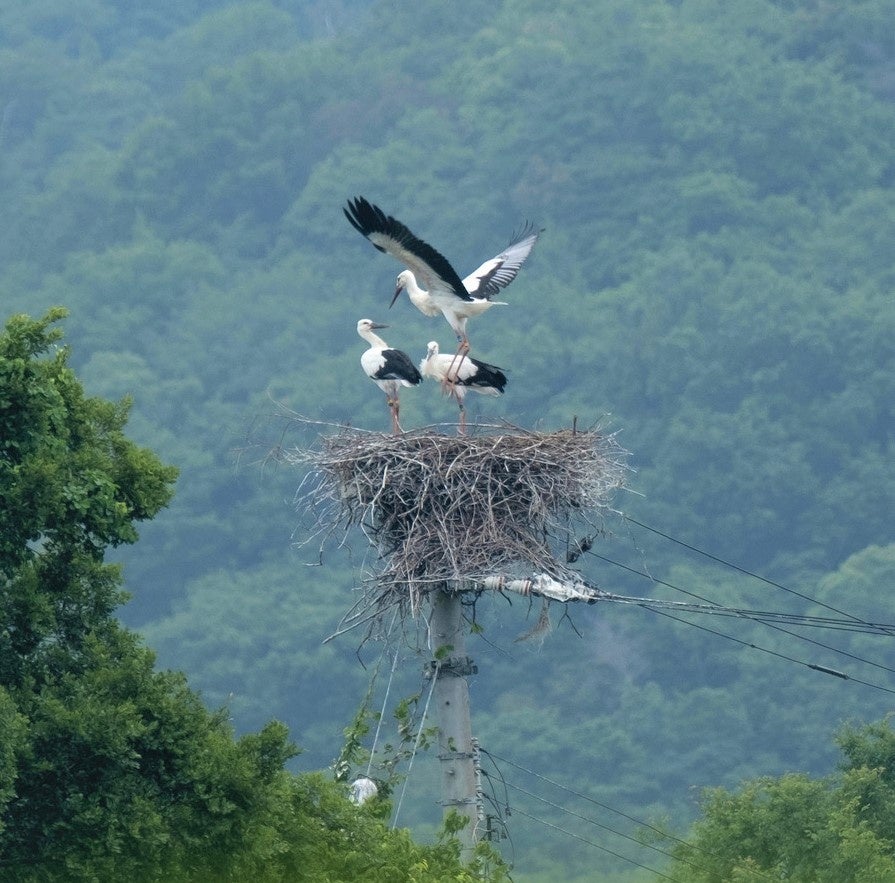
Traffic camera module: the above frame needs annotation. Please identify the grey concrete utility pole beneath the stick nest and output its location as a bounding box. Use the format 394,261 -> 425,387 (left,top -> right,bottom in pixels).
428,587 -> 482,862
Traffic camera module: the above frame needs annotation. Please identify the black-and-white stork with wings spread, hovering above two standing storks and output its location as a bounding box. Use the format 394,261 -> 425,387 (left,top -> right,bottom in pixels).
343,196 -> 541,353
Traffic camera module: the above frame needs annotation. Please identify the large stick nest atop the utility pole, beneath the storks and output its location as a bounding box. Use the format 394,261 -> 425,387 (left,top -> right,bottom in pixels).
287,427 -> 625,607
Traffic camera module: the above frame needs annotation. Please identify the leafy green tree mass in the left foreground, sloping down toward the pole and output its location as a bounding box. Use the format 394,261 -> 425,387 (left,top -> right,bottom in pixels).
0,309 -> 502,881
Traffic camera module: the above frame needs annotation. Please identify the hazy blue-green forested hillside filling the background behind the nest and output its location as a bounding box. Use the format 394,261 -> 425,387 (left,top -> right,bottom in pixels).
0,0 -> 895,883
